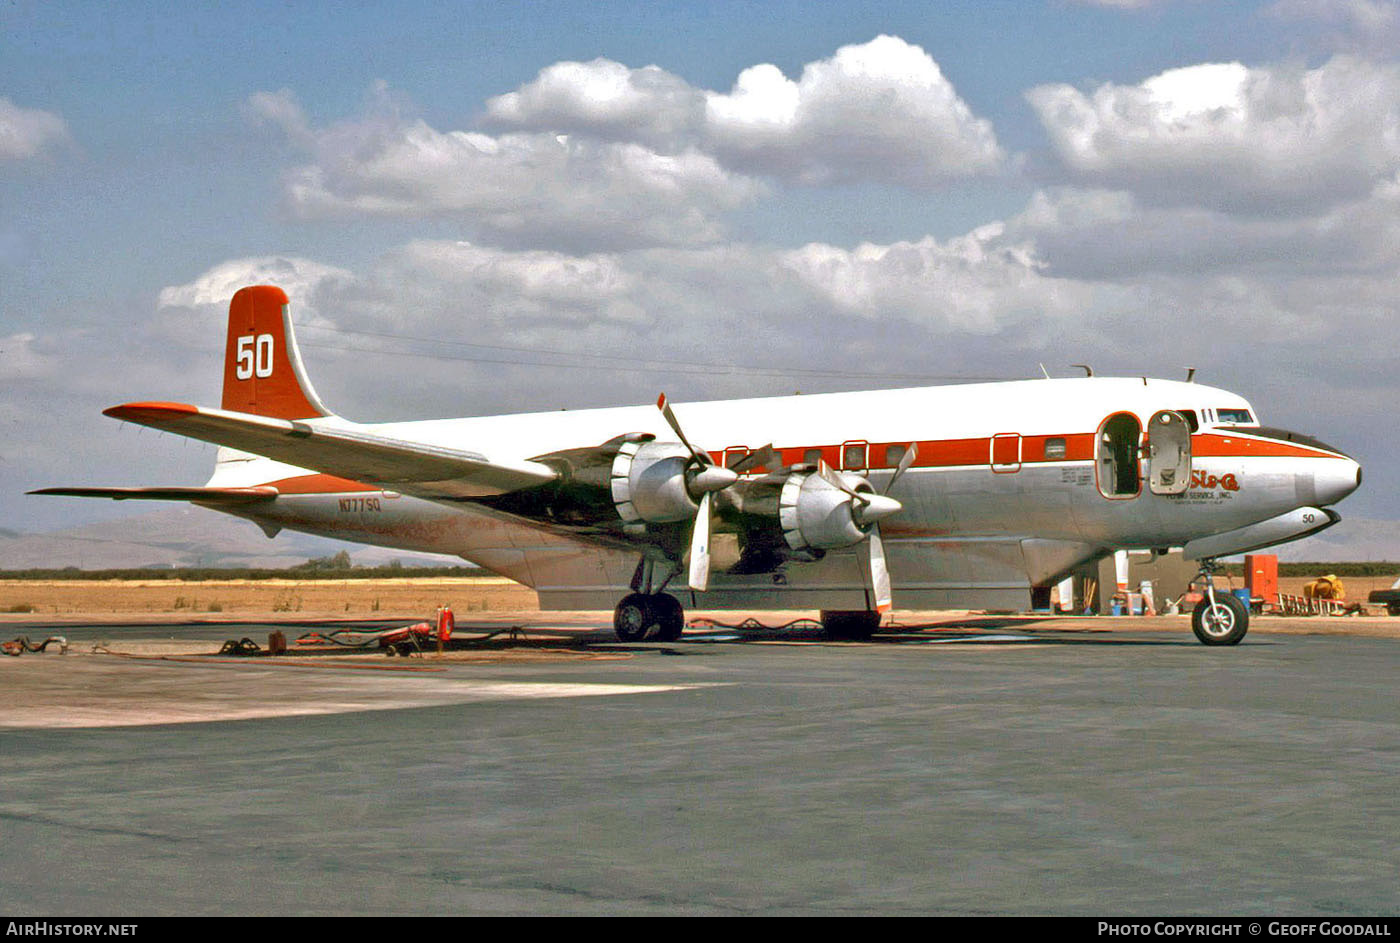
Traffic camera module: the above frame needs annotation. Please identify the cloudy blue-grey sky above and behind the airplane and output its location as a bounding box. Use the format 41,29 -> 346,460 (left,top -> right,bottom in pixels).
0,0 -> 1400,532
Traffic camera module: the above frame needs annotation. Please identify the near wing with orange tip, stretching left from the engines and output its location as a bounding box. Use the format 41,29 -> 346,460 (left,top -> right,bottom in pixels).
104,403 -> 556,499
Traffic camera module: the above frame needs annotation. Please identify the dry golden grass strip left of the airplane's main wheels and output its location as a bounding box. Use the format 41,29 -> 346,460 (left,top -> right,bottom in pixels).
0,576 -> 539,620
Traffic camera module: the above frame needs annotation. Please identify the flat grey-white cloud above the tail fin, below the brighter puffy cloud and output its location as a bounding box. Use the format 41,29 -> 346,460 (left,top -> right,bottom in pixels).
248,83 -> 760,248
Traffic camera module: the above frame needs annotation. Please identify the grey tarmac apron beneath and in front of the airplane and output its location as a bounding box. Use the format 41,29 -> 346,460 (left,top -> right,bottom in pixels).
0,613 -> 1400,918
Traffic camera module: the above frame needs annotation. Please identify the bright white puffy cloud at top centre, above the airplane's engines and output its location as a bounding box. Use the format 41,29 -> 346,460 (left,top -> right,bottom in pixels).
487,36 -> 1005,189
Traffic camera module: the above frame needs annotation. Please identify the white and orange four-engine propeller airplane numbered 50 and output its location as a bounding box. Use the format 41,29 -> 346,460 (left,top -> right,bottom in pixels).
31,285 -> 1361,645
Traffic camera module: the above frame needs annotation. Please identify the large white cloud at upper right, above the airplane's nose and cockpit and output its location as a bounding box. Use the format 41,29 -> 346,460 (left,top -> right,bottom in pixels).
1026,56 -> 1400,214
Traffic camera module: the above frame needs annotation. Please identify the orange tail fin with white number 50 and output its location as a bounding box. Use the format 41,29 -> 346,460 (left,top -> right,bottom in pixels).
223,285 -> 330,420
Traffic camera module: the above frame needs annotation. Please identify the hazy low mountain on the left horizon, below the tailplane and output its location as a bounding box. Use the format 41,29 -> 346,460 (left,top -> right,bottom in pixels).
0,505 -> 463,569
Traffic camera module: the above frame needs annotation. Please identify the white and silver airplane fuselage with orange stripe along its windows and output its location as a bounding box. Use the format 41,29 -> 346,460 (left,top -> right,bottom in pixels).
197,378 -> 1359,609
